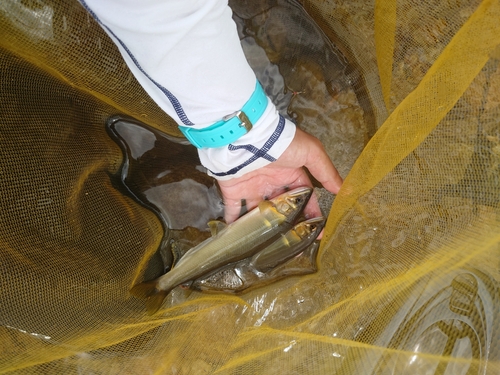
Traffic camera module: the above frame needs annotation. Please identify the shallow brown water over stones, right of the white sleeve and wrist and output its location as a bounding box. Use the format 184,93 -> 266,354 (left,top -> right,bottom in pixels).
230,1 -> 373,177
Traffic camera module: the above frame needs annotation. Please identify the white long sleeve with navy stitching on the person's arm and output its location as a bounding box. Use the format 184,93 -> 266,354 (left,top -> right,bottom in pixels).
80,0 -> 295,180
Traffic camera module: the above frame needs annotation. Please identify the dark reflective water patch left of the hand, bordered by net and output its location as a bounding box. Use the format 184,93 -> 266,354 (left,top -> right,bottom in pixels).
107,116 -> 223,278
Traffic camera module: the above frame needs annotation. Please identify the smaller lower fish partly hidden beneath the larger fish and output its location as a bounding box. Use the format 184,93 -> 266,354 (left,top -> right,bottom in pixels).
187,217 -> 325,293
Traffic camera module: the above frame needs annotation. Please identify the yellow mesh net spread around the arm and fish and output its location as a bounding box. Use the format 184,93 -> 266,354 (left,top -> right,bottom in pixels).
0,0 -> 500,375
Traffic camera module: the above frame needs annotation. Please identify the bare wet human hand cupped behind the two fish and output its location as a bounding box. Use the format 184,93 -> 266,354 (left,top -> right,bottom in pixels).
218,128 -> 342,232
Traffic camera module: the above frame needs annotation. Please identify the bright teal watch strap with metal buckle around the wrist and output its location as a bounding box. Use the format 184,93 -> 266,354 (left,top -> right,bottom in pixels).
179,82 -> 267,148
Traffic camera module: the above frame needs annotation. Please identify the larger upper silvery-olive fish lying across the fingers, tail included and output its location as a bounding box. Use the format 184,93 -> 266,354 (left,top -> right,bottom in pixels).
130,187 -> 313,315
